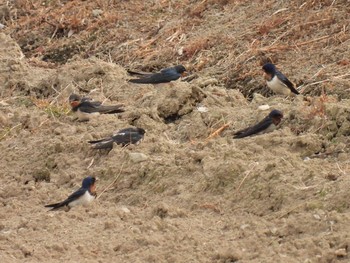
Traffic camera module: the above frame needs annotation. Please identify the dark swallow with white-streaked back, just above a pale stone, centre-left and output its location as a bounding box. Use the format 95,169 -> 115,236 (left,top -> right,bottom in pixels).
88,128 -> 146,150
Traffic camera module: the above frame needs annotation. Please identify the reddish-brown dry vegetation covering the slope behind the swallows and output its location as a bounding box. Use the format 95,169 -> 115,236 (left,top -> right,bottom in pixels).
3,0 -> 350,98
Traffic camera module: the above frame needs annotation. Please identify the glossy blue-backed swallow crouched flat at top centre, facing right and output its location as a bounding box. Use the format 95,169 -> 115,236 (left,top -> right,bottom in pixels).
128,65 -> 186,84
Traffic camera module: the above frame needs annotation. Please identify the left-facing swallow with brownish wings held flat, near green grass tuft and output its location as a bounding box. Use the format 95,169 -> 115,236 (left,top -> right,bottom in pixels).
69,94 -> 124,121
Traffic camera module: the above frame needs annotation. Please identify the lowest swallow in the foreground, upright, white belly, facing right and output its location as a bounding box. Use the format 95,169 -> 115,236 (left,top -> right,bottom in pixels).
45,176 -> 96,211
